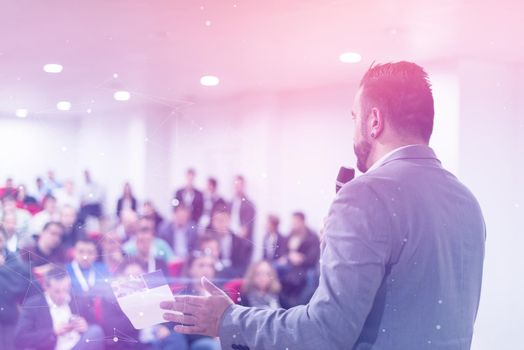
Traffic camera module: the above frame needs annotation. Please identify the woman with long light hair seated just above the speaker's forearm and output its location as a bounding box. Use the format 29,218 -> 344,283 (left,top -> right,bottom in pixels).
240,260 -> 282,309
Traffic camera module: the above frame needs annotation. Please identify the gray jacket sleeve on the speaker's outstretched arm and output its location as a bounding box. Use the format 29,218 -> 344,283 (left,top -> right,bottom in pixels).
220,180 -> 391,350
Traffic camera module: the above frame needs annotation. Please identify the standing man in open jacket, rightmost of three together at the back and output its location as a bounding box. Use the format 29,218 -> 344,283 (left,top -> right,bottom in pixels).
231,175 -> 256,240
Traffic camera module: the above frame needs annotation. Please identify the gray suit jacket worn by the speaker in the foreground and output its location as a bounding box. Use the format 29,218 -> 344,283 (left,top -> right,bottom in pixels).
220,145 -> 485,350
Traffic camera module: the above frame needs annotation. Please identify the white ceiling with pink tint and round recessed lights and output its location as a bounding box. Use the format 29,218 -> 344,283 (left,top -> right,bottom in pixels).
0,0 -> 524,116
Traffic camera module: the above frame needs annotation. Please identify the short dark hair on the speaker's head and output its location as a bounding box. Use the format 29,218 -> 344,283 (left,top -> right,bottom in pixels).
360,61 -> 435,142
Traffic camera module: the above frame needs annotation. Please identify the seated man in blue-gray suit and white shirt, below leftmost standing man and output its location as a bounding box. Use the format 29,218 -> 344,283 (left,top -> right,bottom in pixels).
159,203 -> 198,259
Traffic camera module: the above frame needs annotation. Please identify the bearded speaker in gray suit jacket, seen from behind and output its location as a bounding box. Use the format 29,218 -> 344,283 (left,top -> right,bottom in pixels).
162,62 -> 485,350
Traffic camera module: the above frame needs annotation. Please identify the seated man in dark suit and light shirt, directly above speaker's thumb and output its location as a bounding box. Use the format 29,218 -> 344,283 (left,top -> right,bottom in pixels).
206,203 -> 253,278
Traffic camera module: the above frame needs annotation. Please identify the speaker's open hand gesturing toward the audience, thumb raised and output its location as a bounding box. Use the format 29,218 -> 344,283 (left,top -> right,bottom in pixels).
160,277 -> 234,337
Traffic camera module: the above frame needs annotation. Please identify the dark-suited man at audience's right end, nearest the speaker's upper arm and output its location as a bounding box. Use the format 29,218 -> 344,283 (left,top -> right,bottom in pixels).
277,212 -> 320,308
